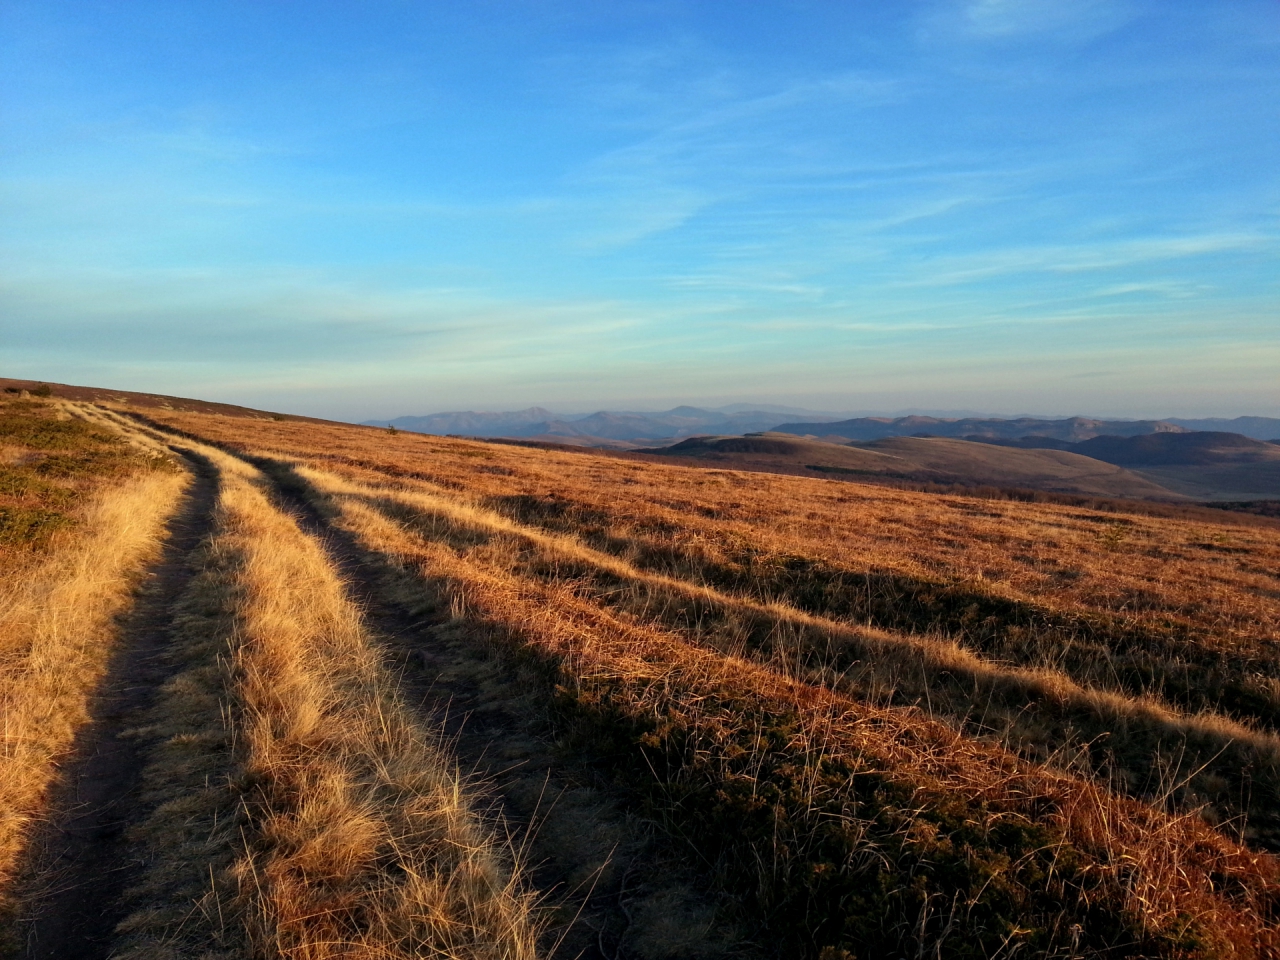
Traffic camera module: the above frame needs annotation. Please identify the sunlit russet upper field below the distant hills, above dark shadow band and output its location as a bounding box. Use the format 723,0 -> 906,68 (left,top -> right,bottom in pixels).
140,413 -> 1280,657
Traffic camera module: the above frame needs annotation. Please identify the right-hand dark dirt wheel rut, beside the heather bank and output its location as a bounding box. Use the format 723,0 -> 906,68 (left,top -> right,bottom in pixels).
253,457 -> 756,960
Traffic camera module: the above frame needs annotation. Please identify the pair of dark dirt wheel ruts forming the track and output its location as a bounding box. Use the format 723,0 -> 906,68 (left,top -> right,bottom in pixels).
10,419 -> 751,960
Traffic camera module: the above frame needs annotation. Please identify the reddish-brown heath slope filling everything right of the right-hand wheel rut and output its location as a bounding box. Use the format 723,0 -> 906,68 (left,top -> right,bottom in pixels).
102,413 -> 1280,957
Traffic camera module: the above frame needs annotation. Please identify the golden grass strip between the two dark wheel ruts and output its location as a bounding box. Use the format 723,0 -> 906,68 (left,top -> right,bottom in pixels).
101,424 -> 536,960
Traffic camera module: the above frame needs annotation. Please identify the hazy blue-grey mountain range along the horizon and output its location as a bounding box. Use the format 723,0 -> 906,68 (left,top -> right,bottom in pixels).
366,403 -> 1280,447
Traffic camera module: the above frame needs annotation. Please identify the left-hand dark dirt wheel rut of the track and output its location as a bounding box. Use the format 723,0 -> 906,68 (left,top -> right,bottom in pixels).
18,447 -> 218,960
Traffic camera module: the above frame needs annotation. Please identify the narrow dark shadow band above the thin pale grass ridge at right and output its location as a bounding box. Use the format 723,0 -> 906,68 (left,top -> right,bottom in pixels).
488,494 -> 1280,731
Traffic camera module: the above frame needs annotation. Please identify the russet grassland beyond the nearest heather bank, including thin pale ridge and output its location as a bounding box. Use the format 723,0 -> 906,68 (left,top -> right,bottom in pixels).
145,417 -> 1280,829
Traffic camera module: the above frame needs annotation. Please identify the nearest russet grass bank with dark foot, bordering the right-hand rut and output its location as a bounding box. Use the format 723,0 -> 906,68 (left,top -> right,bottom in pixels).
299,474 -> 1280,957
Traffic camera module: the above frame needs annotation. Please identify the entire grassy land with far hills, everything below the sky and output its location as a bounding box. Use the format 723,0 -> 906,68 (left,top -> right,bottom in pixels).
0,381 -> 1280,960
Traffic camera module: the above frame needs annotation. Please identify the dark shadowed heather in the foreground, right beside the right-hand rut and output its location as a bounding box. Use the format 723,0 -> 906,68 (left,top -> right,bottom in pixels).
270,463 -> 1280,957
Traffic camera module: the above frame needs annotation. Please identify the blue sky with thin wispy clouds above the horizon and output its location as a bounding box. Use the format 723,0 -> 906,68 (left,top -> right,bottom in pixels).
0,0 -> 1280,420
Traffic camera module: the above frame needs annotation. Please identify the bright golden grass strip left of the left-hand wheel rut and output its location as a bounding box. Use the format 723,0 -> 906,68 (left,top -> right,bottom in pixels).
0,442 -> 189,926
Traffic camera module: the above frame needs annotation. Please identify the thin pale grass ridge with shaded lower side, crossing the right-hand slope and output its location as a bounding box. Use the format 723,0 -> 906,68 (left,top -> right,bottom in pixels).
298,467 -> 1280,840
